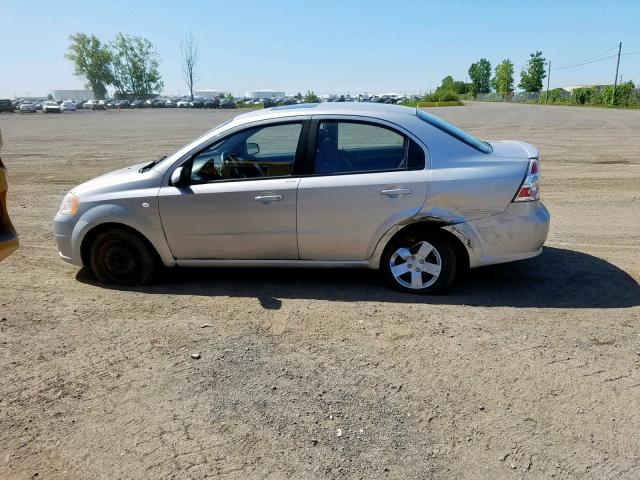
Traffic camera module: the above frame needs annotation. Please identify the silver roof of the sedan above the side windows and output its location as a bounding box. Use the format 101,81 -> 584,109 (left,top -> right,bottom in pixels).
233,102 -> 416,123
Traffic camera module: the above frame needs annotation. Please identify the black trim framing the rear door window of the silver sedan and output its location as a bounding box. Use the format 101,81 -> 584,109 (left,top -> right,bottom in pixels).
303,116 -> 428,177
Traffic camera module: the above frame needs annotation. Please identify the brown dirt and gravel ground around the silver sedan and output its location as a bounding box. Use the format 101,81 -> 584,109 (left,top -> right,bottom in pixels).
0,104 -> 640,479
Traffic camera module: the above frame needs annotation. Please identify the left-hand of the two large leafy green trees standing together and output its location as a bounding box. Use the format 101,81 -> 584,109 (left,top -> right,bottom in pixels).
65,33 -> 113,99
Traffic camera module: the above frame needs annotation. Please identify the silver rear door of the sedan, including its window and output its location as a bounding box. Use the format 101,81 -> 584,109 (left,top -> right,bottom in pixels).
297,116 -> 428,260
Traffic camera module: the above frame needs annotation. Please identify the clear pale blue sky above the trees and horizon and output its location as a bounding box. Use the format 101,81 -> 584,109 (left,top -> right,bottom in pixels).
0,0 -> 640,98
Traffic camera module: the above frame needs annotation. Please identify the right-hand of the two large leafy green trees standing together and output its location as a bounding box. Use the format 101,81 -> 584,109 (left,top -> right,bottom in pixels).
110,33 -> 164,98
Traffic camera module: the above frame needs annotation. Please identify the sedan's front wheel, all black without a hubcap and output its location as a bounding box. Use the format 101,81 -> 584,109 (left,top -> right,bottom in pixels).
90,228 -> 159,286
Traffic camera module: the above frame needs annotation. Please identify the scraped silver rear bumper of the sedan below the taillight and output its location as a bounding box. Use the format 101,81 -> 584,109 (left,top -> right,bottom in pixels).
444,201 -> 551,268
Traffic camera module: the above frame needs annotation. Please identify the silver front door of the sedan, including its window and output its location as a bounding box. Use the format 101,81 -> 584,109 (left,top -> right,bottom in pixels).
159,121 -> 304,260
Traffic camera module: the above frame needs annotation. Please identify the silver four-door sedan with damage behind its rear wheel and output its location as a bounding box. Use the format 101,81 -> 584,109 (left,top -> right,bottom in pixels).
54,103 -> 549,293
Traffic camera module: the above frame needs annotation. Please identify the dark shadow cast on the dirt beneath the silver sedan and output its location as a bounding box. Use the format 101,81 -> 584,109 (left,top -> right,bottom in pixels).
76,247 -> 640,310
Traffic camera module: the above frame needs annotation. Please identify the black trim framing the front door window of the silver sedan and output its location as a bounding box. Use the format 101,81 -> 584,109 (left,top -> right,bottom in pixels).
179,118 -> 311,187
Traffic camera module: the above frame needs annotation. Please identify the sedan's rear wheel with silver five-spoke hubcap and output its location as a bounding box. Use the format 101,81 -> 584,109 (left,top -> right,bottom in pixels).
380,231 -> 458,294
